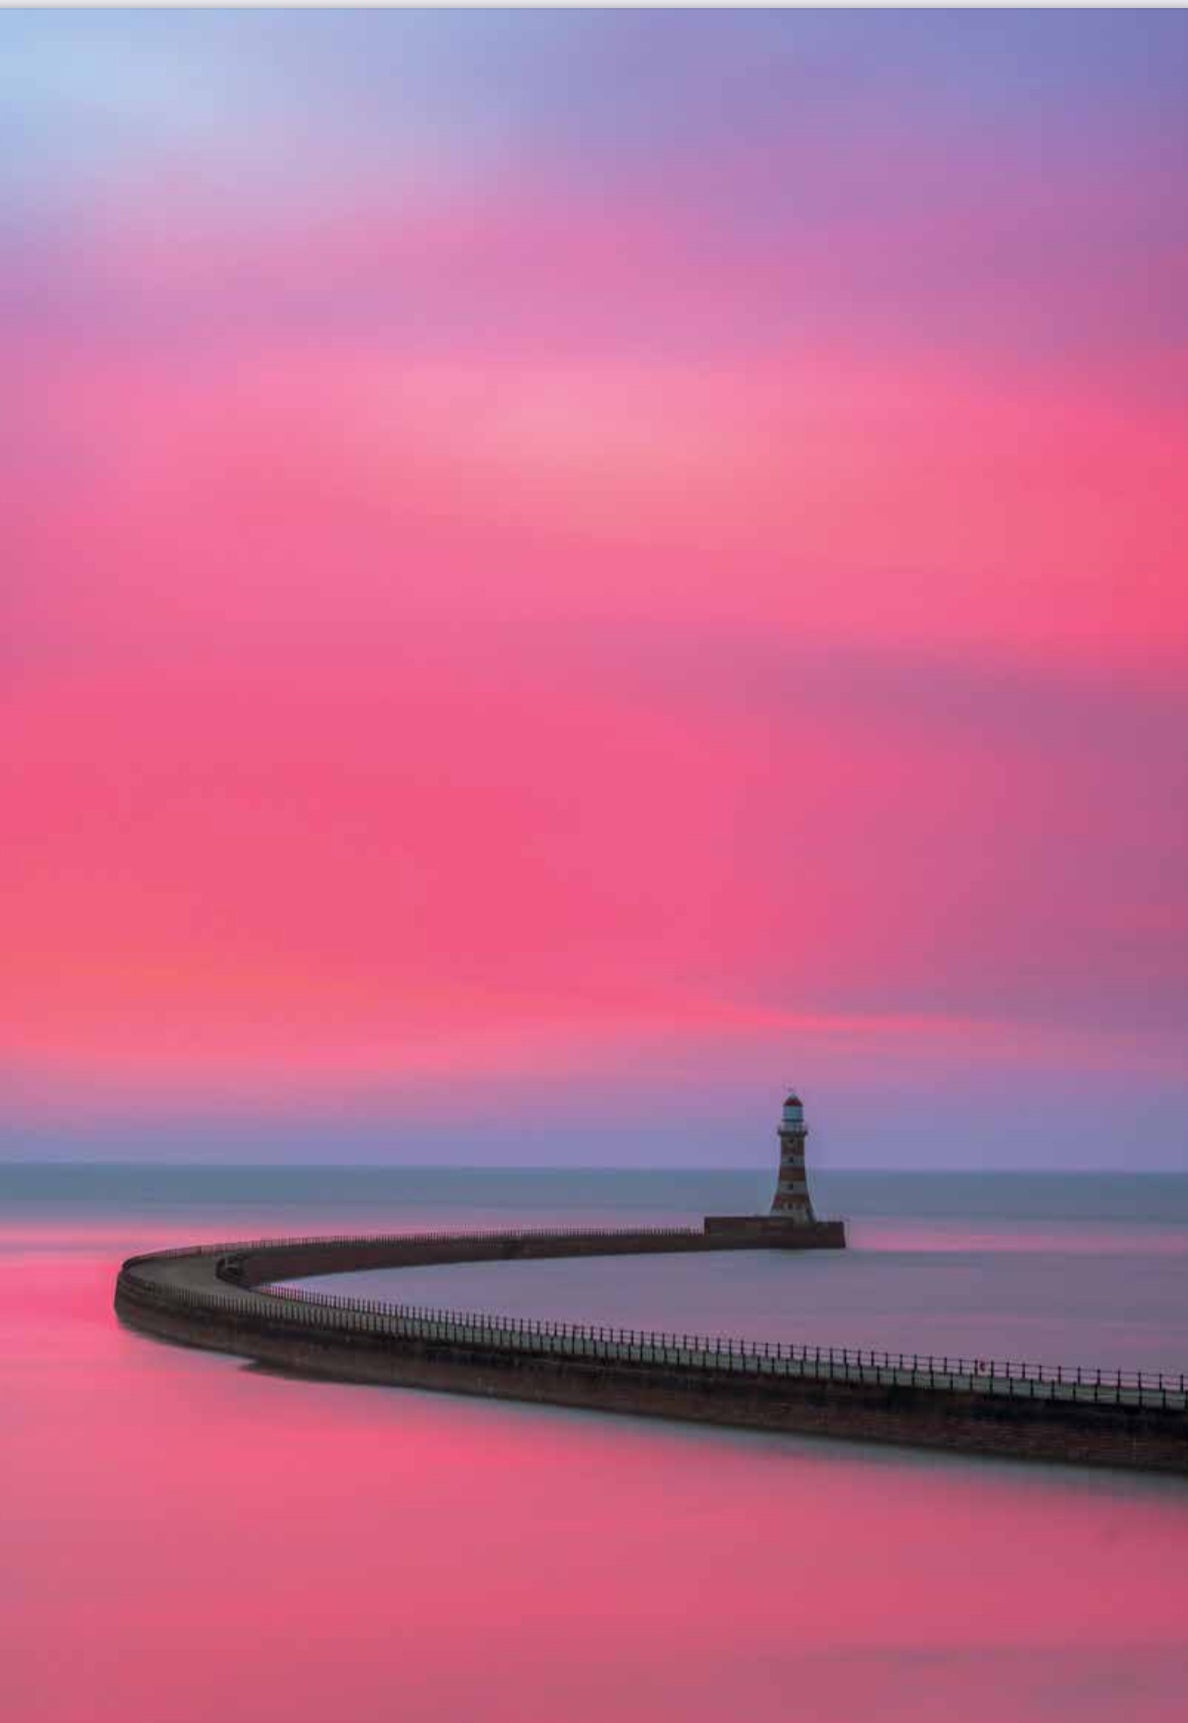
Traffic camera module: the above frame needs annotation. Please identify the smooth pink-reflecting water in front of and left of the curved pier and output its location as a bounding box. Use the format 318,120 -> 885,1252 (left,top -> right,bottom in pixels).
0,1185 -> 1188,1723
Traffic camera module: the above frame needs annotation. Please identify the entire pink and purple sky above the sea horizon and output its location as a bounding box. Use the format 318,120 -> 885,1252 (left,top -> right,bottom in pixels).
0,10 -> 1188,1170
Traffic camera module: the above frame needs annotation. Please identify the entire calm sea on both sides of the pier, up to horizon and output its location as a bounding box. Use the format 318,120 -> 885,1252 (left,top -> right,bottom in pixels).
0,1166 -> 1188,1723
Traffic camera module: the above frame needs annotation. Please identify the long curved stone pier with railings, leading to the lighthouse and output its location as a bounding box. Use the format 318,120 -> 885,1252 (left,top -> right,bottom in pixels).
116,1222 -> 1188,1473
